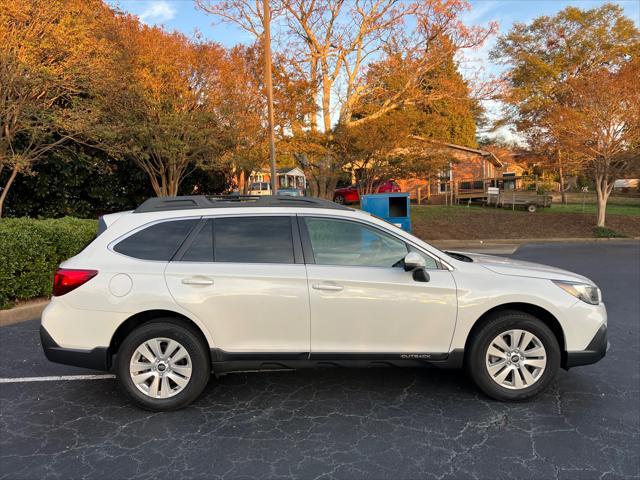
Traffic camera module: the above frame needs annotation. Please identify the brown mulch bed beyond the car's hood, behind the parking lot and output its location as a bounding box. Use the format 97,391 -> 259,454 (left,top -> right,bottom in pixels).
412,207 -> 640,240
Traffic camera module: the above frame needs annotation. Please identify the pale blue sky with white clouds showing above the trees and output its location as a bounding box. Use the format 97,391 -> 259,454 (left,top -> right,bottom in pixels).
107,0 -> 640,142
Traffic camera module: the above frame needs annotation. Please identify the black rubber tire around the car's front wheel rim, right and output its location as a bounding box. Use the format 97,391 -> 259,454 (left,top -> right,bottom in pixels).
465,311 -> 561,401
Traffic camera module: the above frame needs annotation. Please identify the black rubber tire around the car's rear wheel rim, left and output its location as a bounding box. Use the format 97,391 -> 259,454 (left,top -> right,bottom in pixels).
116,318 -> 211,412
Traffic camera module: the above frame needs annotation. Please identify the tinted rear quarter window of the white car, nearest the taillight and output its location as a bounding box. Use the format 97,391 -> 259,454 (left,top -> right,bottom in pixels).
113,218 -> 200,262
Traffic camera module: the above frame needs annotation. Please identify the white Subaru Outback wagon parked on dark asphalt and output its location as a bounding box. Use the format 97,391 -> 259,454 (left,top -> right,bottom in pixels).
41,196 -> 608,410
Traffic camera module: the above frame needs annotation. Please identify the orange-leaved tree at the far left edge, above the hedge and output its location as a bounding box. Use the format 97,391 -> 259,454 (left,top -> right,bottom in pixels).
0,0 -> 116,216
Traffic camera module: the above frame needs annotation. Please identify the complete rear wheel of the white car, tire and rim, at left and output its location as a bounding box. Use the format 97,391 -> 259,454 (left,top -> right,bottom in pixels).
117,319 -> 211,411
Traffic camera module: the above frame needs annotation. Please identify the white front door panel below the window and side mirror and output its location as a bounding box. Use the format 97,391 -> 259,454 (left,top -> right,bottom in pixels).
307,265 -> 457,353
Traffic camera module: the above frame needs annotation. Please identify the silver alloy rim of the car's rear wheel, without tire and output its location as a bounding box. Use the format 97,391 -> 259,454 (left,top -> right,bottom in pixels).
129,338 -> 192,398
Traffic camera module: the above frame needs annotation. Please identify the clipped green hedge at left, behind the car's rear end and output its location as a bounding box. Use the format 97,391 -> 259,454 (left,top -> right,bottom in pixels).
0,217 -> 98,308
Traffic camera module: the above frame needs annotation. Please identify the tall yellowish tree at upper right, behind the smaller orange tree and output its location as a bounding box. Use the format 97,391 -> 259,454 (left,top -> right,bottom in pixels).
491,4 -> 640,202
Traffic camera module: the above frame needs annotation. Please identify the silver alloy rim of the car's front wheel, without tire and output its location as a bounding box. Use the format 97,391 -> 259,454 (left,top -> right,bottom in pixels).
486,329 -> 547,390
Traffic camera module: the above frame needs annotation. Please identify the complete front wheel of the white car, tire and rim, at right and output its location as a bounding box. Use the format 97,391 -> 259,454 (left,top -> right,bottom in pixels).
466,311 -> 560,401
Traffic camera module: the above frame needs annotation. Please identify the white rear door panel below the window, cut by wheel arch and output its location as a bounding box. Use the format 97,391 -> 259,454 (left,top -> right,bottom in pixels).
165,262 -> 309,352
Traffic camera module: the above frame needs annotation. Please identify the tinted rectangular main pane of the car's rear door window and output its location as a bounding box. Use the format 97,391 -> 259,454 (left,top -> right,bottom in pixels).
213,216 -> 295,263
